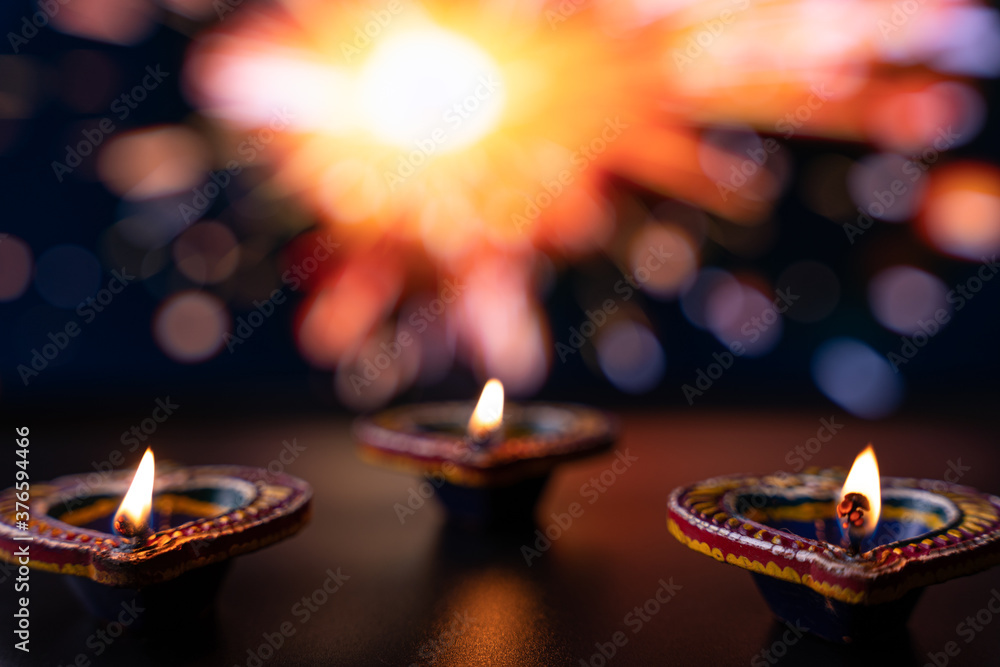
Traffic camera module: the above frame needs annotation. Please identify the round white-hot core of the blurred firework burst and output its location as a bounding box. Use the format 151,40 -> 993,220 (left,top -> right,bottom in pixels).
359,28 -> 504,153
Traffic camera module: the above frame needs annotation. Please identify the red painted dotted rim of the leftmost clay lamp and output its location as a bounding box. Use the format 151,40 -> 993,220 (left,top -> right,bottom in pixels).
0,466 -> 312,588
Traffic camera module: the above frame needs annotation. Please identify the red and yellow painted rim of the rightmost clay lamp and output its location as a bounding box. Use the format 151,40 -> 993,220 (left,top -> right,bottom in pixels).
667,471 -> 1000,605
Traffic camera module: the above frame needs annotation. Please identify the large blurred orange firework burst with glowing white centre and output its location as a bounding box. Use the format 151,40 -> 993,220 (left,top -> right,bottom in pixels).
170,0 -> 1000,405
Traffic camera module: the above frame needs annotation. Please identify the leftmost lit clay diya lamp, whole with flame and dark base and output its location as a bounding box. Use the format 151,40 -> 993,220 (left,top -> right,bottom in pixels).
0,450 -> 312,627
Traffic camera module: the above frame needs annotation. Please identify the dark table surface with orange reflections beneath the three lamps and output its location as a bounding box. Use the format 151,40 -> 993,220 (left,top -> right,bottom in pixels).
0,412 -> 1000,667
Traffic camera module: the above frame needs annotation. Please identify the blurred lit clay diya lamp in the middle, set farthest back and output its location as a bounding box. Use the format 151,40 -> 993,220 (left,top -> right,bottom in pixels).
354,380 -> 617,528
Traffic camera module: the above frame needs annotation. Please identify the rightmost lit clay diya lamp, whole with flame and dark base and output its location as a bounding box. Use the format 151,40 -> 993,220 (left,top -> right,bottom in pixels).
667,446 -> 1000,642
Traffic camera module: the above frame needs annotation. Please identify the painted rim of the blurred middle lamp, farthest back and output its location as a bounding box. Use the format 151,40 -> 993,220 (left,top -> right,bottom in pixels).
354,402 -> 618,486
